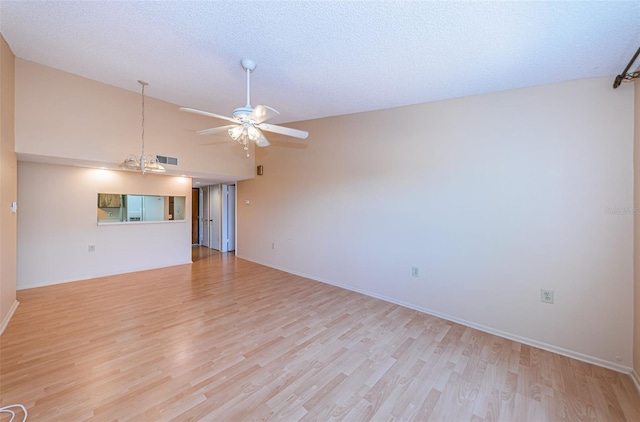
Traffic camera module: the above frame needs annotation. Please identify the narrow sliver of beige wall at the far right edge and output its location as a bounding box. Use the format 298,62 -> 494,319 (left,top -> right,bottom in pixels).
633,81 -> 640,378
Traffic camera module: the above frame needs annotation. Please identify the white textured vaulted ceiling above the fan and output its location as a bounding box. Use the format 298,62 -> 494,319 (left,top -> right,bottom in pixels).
0,0 -> 640,123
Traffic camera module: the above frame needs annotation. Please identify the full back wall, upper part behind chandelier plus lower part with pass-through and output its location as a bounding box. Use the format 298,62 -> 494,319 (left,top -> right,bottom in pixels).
14,58 -> 255,289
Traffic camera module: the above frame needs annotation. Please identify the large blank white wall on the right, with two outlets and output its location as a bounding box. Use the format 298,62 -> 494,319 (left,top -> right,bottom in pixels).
236,78 -> 633,371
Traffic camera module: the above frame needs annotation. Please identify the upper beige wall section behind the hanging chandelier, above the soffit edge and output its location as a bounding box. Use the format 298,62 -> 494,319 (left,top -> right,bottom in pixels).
16,58 -> 254,181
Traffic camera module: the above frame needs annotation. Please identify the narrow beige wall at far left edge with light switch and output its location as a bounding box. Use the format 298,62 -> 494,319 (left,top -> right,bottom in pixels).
0,35 -> 17,334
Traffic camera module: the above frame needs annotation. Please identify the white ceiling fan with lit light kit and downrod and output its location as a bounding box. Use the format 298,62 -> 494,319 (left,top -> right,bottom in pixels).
180,59 -> 309,157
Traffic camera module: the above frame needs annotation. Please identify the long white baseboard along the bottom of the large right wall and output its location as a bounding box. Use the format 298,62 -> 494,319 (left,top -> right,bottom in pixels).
236,254 -> 640,374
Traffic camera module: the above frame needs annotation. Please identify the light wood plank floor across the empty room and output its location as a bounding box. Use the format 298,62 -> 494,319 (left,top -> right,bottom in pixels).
0,248 -> 640,421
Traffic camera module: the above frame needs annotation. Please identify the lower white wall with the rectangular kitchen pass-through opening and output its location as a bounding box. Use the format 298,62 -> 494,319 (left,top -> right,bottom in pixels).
17,162 -> 191,289
